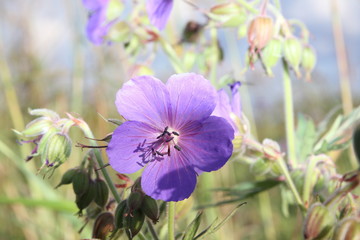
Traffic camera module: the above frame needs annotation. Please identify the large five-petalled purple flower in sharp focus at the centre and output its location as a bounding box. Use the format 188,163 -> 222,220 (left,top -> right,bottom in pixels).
107,73 -> 234,201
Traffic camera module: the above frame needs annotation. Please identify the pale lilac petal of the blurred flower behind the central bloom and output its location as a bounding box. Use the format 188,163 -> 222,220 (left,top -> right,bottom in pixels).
211,89 -> 237,130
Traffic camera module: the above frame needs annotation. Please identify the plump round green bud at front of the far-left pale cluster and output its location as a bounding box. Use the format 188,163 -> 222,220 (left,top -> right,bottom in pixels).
46,133 -> 71,164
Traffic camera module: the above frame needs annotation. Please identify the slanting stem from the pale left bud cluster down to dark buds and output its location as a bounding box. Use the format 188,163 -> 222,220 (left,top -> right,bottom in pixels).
80,122 -> 121,203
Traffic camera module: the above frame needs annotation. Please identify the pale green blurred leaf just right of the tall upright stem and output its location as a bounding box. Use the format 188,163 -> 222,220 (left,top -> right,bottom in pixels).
296,114 -> 316,162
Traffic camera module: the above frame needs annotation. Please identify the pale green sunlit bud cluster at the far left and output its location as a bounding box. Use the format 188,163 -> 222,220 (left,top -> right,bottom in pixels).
15,109 -> 75,170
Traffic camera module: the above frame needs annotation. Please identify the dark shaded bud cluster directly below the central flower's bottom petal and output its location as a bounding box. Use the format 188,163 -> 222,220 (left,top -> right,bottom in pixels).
115,178 -> 159,239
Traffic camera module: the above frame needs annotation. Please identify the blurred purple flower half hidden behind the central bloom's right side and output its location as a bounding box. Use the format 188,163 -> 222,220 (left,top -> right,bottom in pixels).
212,82 -> 246,149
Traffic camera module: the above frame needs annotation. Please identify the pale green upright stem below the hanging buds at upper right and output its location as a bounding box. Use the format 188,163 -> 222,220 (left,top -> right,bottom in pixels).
283,60 -> 297,166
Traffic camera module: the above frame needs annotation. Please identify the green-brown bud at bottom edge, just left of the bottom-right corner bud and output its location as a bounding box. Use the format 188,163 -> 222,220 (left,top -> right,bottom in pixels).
303,203 -> 336,240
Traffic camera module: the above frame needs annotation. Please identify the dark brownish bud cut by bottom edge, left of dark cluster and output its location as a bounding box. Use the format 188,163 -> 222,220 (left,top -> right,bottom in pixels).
92,212 -> 115,239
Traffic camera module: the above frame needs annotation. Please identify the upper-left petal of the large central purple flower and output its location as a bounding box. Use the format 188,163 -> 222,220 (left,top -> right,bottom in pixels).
115,76 -> 171,128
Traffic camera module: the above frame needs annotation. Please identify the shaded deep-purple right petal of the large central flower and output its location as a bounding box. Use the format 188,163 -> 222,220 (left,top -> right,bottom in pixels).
178,116 -> 234,173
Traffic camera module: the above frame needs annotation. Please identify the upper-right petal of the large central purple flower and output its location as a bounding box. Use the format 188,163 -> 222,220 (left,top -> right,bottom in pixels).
167,73 -> 216,129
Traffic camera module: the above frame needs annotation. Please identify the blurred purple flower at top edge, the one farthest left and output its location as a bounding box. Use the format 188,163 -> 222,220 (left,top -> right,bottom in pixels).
83,0 -> 114,45
